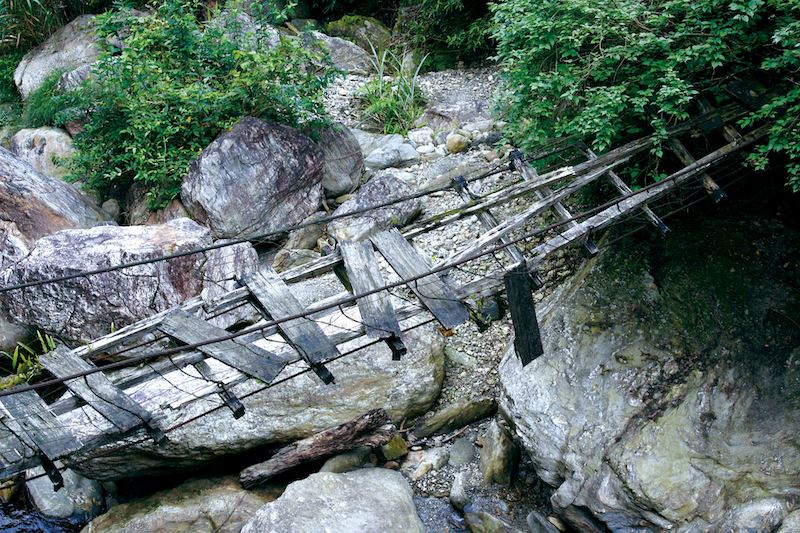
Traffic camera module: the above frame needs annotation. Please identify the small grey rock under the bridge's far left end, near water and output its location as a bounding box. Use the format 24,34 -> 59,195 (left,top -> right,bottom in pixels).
25,467 -> 105,525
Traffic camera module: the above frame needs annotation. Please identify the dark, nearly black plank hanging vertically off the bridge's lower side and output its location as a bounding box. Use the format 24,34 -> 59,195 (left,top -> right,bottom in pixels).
503,263 -> 544,366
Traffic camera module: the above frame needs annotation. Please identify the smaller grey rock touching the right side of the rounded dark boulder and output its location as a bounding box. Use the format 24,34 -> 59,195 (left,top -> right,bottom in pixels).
319,123 -> 364,198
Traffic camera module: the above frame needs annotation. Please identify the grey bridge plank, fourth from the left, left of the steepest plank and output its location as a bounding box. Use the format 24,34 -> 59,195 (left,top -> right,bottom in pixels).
242,267 -> 340,383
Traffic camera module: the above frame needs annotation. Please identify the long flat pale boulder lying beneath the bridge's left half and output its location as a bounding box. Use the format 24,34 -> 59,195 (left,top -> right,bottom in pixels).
68,324 -> 444,480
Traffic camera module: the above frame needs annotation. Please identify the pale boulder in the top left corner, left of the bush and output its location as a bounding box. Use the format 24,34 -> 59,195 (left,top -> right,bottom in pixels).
14,15 -> 100,99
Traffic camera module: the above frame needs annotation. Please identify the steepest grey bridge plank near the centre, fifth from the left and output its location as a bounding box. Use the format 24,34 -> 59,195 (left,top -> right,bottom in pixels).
341,241 -> 406,360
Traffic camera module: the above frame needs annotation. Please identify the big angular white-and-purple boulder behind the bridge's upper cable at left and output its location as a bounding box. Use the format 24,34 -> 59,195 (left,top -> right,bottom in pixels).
3,218 -> 258,342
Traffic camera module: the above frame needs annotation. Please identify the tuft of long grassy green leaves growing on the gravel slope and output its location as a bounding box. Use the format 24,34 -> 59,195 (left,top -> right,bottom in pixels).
358,45 -> 425,134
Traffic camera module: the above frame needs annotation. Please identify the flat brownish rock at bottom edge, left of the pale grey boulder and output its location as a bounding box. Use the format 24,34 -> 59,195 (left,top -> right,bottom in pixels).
81,477 -> 277,533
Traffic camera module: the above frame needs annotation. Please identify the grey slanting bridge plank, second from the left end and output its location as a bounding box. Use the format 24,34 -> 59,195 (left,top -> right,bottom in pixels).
39,346 -> 164,442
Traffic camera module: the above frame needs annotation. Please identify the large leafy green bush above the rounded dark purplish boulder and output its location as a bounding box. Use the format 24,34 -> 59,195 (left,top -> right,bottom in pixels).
63,0 -> 332,209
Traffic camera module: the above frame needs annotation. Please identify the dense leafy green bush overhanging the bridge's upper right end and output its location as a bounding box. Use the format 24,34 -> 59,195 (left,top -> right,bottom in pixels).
493,0 -> 800,188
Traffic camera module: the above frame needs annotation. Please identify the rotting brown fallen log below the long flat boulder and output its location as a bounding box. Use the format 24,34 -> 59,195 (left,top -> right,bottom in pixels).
239,409 -> 395,489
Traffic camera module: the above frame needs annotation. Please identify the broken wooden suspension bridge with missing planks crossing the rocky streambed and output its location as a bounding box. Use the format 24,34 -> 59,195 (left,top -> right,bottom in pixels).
0,98 -> 767,488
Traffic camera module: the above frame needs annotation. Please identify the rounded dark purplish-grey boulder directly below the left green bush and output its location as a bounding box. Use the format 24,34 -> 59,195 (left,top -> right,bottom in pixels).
181,117 -> 323,238
